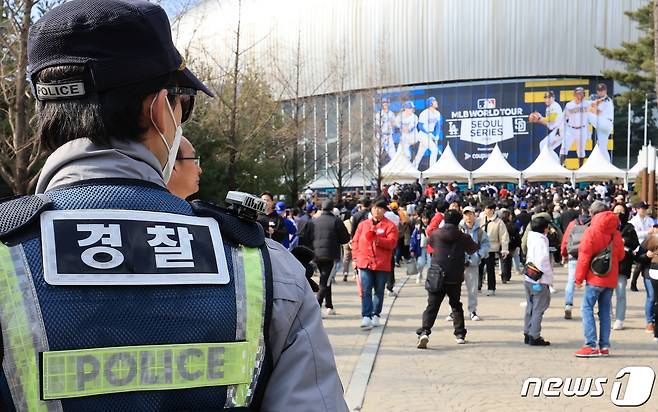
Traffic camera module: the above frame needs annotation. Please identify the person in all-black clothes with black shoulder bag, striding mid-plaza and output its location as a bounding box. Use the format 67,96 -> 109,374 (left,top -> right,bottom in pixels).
416,210 -> 479,349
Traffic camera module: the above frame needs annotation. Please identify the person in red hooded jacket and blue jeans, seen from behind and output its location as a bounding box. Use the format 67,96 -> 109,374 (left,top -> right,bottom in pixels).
575,201 -> 624,358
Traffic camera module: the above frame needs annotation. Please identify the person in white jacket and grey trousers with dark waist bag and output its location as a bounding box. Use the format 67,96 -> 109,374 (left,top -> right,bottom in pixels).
523,217 -> 554,346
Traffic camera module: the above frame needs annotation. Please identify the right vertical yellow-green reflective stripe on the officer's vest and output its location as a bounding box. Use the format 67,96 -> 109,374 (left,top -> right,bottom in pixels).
234,248 -> 265,406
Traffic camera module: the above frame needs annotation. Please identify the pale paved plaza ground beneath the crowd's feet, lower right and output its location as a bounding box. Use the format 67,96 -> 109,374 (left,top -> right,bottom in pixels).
324,268 -> 658,412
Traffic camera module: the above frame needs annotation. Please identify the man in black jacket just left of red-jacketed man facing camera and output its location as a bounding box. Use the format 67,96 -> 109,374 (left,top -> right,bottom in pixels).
305,200 -> 350,315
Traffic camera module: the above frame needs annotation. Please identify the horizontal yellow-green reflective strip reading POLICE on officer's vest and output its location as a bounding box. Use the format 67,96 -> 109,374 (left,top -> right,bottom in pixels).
42,342 -> 252,399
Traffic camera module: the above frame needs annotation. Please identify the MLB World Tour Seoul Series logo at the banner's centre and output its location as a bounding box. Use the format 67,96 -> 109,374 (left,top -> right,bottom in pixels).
446,98 -> 528,145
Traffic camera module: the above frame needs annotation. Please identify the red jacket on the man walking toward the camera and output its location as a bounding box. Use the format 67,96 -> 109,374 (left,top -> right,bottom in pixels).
352,218 -> 398,272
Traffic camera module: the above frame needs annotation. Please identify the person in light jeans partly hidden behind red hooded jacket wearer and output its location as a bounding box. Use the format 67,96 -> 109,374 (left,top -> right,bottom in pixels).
560,203 -> 605,319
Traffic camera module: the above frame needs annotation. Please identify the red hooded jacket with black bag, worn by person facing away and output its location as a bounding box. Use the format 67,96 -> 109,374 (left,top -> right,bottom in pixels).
576,211 -> 624,288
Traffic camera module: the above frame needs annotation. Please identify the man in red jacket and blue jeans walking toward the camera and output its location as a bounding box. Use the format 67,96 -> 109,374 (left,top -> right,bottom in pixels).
352,199 -> 398,329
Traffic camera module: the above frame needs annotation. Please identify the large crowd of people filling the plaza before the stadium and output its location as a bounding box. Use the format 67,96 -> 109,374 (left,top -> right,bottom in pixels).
261,181 -> 658,357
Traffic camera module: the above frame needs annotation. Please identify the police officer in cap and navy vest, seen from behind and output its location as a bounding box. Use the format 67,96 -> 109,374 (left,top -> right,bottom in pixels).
0,0 -> 347,412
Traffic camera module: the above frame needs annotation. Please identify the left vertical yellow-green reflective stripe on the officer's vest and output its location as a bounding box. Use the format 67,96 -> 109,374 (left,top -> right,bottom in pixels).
0,243 -> 50,412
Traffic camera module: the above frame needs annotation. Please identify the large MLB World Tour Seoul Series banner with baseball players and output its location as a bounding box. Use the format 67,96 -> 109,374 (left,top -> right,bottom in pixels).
374,78 -> 614,170
